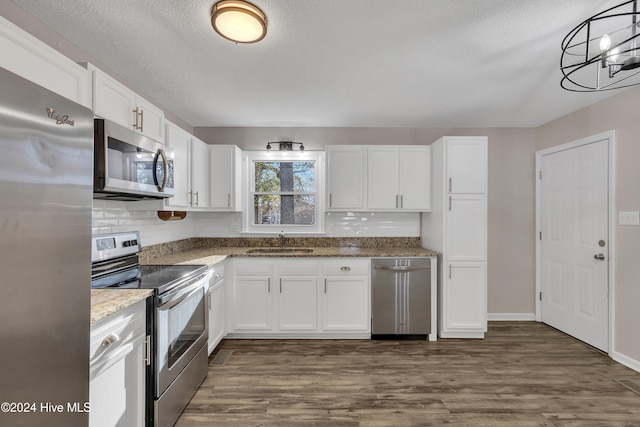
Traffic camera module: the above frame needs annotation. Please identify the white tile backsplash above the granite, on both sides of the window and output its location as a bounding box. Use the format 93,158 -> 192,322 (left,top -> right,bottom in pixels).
92,200 -> 420,246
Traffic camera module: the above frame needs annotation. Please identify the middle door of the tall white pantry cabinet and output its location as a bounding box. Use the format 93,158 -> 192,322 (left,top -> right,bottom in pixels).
446,194 -> 487,261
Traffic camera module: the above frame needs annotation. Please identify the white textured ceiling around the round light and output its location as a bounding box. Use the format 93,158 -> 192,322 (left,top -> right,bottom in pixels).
14,0 -> 620,127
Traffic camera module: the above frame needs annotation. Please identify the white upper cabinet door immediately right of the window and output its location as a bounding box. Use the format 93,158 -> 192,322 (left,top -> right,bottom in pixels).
327,145 -> 366,210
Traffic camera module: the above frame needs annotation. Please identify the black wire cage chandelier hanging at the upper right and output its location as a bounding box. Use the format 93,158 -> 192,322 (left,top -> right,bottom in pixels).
560,0 -> 640,92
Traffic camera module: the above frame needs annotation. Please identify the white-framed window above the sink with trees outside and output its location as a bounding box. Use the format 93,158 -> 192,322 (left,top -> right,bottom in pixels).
245,152 -> 323,233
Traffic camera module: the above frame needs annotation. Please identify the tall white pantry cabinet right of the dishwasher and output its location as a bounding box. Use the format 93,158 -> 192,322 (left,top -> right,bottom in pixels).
422,136 -> 488,338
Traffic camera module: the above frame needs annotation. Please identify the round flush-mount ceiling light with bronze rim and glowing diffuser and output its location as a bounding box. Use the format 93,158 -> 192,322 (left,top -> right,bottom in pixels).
211,0 -> 267,43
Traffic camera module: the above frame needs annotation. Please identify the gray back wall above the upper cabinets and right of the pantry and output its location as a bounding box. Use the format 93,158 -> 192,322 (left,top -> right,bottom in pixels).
194,128 -> 535,314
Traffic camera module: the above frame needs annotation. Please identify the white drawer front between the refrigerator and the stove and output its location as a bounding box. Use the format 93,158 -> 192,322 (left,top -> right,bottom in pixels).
89,301 -> 146,364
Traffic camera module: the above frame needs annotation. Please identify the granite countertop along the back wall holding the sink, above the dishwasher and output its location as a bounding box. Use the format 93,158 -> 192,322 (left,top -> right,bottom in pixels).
141,247 -> 440,265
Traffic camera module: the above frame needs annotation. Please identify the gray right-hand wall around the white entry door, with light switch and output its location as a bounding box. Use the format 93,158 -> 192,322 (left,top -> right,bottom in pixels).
535,87 -> 640,364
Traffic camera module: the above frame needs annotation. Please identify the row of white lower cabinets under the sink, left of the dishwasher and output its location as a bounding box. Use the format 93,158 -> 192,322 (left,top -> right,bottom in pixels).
227,258 -> 370,338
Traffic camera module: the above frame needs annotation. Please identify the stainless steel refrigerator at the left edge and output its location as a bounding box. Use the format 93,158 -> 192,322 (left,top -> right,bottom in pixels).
0,67 -> 93,427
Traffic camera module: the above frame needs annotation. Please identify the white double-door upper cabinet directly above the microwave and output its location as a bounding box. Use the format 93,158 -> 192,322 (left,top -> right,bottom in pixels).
89,66 -> 165,142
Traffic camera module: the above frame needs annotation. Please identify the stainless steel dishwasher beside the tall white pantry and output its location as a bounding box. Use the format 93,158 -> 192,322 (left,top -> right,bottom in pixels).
371,258 -> 431,339
